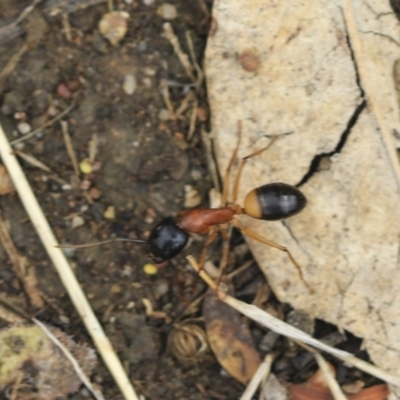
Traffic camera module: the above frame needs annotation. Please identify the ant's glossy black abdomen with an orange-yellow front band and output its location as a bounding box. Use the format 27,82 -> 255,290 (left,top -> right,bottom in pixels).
244,182 -> 307,221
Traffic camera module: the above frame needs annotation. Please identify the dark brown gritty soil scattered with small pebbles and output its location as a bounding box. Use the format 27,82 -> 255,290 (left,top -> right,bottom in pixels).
0,0 -> 382,400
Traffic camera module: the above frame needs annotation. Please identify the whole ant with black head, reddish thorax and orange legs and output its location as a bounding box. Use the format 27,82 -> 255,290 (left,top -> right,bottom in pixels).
65,121 -> 313,292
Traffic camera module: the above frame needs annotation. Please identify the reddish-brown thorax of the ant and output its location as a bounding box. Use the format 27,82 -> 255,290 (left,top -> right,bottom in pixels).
176,207 -> 236,233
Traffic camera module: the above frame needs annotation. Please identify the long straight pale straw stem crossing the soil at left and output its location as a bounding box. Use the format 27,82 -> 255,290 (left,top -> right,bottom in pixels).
0,125 -> 138,400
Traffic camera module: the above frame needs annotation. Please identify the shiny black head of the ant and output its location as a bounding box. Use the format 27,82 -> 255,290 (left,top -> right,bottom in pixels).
146,217 -> 189,264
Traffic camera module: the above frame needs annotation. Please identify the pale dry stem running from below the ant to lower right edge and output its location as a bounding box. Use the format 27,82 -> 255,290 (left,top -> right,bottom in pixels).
187,256 -> 400,387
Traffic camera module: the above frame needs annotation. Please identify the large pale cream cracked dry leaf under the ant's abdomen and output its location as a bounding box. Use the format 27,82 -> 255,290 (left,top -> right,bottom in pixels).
206,0 -> 400,399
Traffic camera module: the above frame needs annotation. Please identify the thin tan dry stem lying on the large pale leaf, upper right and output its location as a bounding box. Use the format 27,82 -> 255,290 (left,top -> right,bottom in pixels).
343,0 -> 400,189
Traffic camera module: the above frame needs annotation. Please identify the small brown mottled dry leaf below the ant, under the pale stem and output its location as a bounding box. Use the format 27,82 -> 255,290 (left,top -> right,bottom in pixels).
203,282 -> 261,383
